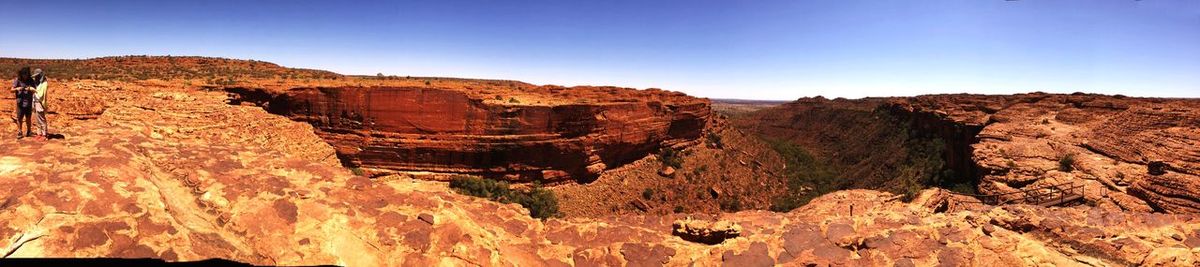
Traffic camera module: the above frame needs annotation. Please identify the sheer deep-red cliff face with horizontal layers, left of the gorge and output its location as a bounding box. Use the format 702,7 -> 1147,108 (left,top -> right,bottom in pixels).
235,87 -> 709,182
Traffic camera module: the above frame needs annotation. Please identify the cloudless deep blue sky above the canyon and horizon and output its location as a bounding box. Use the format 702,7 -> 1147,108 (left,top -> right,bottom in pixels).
0,0 -> 1200,100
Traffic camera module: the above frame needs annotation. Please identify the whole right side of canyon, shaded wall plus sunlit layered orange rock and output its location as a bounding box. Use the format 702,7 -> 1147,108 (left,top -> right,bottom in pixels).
743,93 -> 1200,213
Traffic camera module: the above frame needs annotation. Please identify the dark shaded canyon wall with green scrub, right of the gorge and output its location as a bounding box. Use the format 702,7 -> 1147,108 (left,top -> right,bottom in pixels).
732,97 -> 978,192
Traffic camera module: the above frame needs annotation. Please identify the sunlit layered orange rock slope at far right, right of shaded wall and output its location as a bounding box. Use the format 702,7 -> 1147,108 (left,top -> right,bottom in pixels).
895,94 -> 1200,213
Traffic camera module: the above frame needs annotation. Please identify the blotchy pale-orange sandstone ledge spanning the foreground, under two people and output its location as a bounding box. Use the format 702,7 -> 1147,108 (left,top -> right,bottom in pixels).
0,82 -> 1200,266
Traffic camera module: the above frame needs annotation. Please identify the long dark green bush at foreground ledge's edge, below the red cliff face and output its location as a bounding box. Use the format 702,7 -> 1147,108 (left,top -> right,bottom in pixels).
450,176 -> 559,219
